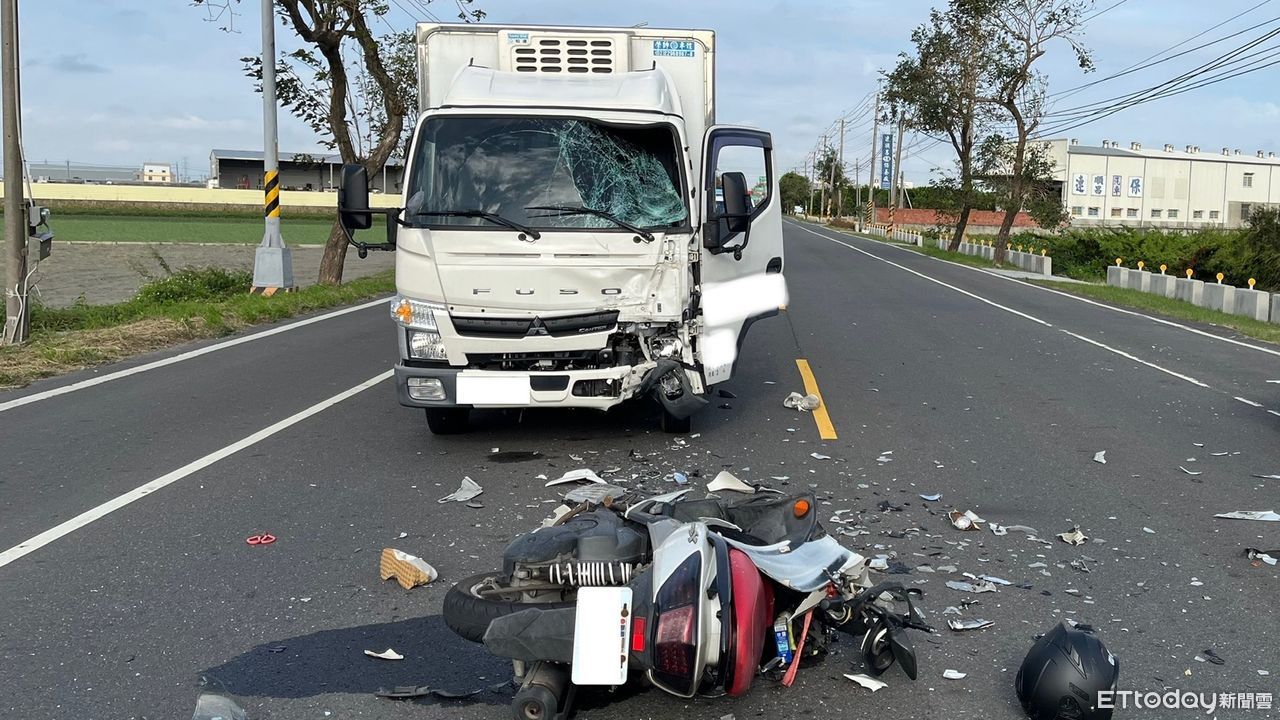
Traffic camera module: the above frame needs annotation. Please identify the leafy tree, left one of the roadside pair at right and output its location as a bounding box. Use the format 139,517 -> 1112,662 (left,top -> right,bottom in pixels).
884,1 -> 995,250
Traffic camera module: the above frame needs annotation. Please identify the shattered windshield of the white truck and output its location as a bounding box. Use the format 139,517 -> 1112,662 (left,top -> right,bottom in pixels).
406,117 -> 689,229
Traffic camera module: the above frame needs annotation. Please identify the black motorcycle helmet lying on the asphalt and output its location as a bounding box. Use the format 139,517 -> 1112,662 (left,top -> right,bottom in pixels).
1014,623 -> 1120,720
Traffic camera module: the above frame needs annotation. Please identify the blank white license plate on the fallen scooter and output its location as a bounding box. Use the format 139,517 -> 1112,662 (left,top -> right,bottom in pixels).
572,588 -> 631,685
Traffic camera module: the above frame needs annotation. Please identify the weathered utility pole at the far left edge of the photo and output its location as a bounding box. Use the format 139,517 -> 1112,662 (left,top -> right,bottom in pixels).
0,0 -> 31,345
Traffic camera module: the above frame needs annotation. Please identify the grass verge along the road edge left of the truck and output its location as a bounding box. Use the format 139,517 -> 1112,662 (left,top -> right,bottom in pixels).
0,270 -> 396,389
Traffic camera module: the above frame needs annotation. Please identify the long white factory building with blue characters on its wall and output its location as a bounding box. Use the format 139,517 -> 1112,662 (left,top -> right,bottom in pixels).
1048,140 -> 1280,228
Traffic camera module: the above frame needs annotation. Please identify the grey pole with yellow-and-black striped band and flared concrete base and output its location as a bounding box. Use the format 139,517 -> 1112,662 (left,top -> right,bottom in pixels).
250,0 -> 297,295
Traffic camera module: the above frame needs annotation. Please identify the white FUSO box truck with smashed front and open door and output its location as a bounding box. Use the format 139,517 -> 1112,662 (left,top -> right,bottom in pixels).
338,23 -> 786,433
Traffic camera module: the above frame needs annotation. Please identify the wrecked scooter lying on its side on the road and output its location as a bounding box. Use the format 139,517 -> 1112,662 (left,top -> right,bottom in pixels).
444,479 -> 932,720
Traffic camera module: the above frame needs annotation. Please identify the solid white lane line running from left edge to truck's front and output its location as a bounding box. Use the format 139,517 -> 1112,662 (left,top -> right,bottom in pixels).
0,370 -> 394,568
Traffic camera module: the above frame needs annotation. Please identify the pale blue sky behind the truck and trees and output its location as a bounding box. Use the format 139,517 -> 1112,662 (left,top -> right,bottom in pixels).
10,0 -> 1280,182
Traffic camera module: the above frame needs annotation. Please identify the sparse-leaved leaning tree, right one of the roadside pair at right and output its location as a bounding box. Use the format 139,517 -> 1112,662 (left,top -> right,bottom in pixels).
972,0 -> 1093,264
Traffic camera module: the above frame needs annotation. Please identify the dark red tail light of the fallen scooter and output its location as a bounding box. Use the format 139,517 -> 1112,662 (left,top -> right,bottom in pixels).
652,553 -> 701,697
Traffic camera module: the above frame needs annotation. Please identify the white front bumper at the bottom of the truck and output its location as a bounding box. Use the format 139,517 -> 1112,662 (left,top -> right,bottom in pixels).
396,361 -> 640,410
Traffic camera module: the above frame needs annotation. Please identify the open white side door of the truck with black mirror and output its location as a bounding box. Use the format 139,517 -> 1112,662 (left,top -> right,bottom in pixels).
699,126 -> 787,386
